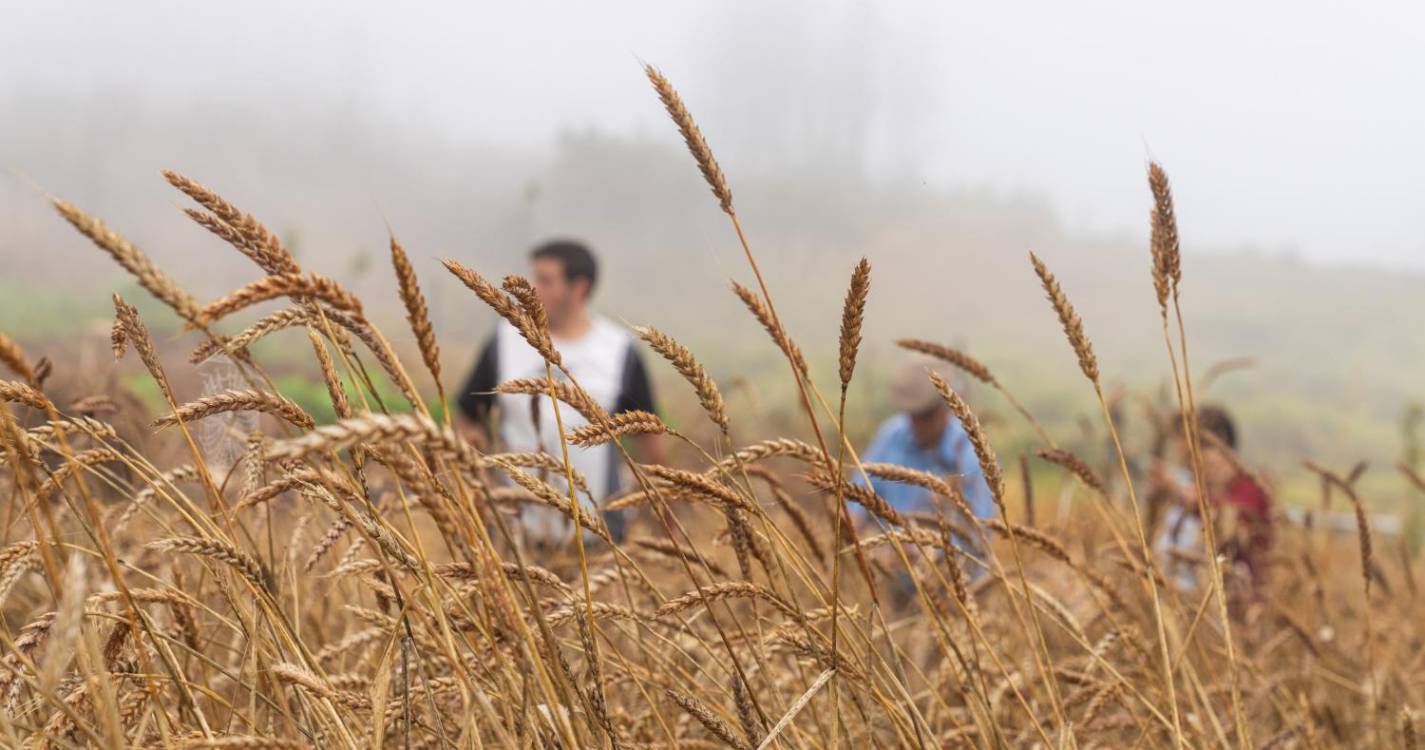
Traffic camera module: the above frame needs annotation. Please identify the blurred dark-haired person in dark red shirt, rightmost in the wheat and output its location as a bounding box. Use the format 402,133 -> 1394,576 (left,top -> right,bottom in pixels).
1150,405 -> 1271,590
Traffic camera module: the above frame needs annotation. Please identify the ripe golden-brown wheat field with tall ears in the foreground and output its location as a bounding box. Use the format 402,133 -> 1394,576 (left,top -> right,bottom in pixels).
0,67 -> 1425,750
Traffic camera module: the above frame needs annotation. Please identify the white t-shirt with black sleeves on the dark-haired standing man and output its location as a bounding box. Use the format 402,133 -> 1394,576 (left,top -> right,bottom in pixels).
459,315 -> 654,536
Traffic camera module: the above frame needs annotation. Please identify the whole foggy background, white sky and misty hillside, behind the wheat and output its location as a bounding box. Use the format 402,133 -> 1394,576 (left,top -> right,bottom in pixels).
0,0 -> 1425,481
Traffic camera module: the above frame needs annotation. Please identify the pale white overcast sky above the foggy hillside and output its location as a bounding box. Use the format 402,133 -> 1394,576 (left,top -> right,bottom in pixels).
11,0 -> 1425,267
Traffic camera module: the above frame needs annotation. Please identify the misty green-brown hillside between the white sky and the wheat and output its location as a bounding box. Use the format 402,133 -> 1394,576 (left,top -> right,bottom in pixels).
0,96 -> 1425,496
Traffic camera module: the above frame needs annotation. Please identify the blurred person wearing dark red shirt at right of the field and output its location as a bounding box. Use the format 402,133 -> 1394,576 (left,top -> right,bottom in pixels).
1153,405 -> 1273,589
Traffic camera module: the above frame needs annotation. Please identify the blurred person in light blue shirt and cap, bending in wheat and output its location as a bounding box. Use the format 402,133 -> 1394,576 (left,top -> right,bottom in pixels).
861,359 -> 995,536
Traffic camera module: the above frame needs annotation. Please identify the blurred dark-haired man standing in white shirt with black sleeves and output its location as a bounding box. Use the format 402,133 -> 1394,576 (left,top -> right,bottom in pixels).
457,240 -> 663,543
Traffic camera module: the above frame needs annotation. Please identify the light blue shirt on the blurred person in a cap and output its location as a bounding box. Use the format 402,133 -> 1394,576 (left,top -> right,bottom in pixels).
861,413 -> 995,527
